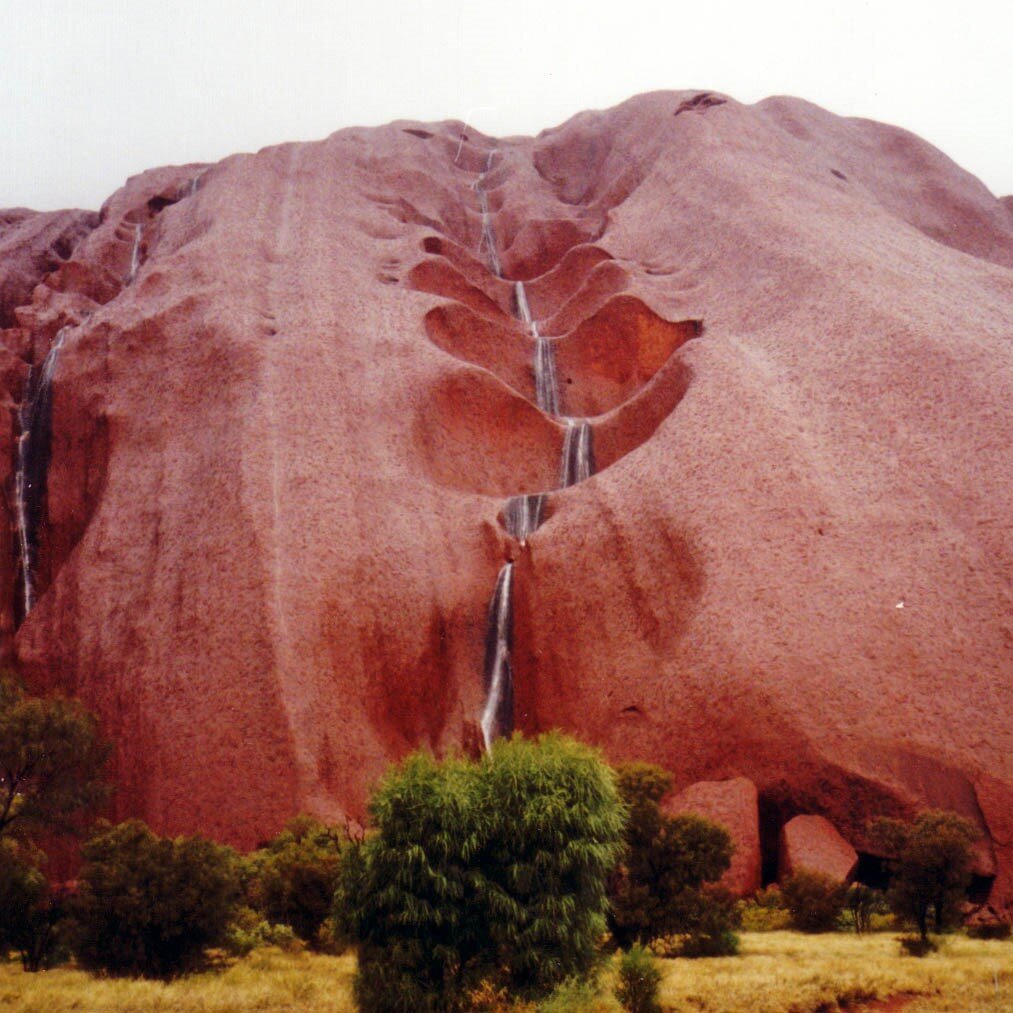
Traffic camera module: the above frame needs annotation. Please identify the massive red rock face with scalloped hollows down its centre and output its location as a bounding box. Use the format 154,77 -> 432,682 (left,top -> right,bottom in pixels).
0,92 -> 1013,903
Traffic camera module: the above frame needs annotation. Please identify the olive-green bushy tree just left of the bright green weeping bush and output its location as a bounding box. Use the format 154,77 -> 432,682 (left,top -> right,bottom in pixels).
246,815 -> 348,946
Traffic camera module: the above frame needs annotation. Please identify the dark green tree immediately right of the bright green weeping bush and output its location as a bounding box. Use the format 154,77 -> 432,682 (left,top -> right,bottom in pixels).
610,764 -> 737,955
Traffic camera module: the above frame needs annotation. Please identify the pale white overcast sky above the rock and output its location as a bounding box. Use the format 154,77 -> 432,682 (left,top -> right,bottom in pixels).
0,0 -> 1013,210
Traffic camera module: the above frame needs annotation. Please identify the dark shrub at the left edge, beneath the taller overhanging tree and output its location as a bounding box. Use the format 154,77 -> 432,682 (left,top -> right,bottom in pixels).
0,840 -> 64,971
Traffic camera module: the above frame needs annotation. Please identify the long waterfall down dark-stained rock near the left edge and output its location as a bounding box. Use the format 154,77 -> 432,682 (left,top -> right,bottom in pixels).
14,327 -> 69,622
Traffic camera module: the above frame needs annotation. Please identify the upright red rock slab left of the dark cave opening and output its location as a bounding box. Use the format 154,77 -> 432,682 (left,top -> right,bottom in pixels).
661,777 -> 762,897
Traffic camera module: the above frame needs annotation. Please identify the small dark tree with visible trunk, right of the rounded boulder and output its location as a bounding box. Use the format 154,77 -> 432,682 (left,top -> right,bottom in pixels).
872,809 -> 979,944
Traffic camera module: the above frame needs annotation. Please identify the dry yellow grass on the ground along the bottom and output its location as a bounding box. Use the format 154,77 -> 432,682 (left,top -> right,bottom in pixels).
0,932 -> 1013,1013
